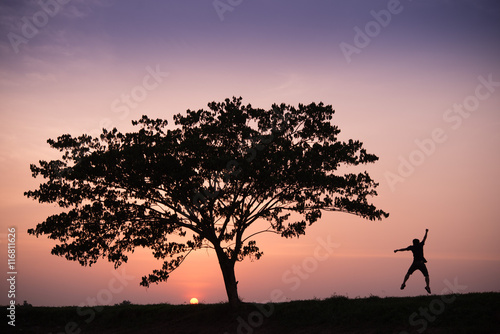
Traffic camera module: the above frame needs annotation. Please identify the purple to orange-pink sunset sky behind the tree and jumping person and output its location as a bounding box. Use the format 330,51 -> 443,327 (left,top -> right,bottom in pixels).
0,0 -> 500,306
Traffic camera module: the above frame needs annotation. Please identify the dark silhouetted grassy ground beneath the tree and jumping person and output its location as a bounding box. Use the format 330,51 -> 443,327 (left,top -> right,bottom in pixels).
2,292 -> 500,334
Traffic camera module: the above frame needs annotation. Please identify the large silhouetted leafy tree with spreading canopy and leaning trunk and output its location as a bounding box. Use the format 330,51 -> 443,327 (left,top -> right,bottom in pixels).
25,97 -> 388,307
